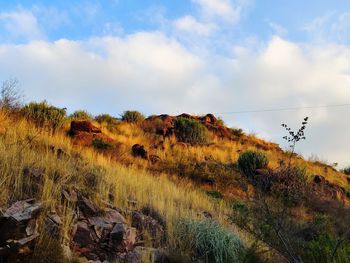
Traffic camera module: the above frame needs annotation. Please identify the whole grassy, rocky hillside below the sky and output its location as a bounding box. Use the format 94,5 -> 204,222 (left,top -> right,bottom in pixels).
0,103 -> 350,263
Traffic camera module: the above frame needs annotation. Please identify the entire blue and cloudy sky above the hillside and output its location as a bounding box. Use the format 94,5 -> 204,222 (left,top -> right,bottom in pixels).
0,0 -> 350,167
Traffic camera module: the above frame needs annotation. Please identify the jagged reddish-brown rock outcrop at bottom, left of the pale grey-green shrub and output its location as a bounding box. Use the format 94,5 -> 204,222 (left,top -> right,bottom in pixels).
63,190 -> 165,263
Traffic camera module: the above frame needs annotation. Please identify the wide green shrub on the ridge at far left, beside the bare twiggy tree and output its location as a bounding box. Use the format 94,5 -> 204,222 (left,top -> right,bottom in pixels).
22,101 -> 66,131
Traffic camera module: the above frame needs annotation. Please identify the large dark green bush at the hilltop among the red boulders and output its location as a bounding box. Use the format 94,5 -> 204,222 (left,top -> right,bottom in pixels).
174,117 -> 210,145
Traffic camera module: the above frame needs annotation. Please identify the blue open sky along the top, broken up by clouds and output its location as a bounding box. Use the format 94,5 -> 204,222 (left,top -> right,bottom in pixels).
0,0 -> 350,44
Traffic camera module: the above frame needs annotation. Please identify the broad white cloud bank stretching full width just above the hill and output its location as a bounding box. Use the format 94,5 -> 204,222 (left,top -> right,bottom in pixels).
0,32 -> 350,164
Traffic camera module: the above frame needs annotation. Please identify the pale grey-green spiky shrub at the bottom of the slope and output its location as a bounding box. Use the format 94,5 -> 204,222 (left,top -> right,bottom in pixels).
175,219 -> 246,263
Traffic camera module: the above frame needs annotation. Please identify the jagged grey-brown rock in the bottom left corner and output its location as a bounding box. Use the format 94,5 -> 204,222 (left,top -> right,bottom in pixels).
0,199 -> 42,261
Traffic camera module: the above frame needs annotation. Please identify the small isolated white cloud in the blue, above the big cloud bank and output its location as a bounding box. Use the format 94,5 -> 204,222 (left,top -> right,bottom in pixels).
174,15 -> 217,36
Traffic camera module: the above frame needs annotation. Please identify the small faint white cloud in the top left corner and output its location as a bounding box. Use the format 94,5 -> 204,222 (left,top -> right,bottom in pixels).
0,9 -> 44,40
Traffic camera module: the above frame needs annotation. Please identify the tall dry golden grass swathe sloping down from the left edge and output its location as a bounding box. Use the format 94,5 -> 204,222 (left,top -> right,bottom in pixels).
0,112 -> 243,260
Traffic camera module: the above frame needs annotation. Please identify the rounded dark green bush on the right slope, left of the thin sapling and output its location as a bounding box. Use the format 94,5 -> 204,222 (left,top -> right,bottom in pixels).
238,151 -> 269,177
